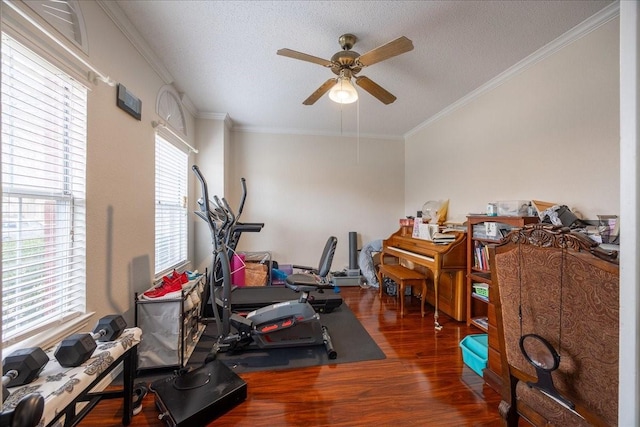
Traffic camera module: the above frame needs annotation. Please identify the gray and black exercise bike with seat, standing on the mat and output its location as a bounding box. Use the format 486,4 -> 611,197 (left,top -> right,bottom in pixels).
192,165 -> 337,364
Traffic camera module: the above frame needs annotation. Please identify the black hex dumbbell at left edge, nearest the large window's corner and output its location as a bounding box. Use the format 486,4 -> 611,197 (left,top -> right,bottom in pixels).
2,347 -> 49,402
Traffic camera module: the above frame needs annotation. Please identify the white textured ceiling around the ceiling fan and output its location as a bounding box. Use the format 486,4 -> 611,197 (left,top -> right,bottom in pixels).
103,0 -> 612,137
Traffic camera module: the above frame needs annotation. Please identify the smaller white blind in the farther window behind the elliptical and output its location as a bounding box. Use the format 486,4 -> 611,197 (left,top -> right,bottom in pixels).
155,135 -> 189,275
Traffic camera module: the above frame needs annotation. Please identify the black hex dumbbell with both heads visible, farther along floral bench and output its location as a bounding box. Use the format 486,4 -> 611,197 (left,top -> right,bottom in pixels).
54,314 -> 127,368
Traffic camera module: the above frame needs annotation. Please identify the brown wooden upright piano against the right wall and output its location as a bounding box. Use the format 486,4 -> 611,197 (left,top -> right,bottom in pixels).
380,226 -> 467,321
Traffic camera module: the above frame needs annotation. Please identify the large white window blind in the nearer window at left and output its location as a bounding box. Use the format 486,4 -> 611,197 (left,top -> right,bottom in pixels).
2,33 -> 87,345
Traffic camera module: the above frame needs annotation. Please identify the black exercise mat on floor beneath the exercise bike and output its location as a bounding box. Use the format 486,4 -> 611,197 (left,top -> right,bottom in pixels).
188,304 -> 386,373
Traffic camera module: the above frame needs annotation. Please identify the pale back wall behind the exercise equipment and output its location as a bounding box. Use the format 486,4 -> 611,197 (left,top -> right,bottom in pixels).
212,132 -> 404,270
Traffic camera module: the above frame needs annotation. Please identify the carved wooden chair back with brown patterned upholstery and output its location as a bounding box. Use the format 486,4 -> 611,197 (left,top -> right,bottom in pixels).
490,224 -> 619,426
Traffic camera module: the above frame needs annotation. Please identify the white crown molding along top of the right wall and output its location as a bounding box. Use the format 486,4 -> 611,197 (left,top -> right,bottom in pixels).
404,1 -> 620,139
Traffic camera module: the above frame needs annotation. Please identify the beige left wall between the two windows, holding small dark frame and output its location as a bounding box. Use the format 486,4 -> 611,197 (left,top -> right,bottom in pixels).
62,2 -> 194,325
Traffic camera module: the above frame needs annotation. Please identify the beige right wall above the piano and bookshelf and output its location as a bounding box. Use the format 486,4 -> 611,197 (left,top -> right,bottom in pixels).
405,18 -> 620,219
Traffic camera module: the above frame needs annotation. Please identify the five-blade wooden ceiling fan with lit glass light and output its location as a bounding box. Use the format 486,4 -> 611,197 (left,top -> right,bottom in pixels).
277,34 -> 413,105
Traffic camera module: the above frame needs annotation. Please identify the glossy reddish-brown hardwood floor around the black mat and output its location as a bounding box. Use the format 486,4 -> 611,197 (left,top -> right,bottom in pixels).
80,287 -> 510,427
